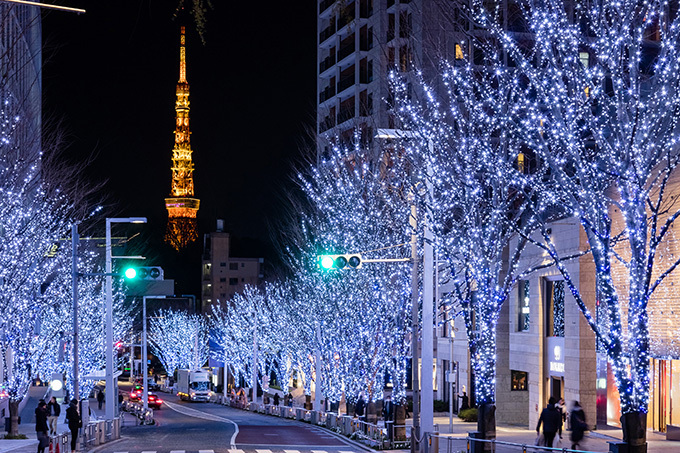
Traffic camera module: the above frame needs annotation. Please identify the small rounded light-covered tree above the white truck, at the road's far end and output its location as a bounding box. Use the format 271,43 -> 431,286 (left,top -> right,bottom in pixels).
149,309 -> 209,374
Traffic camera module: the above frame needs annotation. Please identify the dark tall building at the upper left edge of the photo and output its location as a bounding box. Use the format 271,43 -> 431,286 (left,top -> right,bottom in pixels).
0,2 -> 42,163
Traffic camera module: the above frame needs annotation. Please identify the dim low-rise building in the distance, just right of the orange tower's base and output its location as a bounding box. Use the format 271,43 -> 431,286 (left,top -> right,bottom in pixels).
201,220 -> 264,313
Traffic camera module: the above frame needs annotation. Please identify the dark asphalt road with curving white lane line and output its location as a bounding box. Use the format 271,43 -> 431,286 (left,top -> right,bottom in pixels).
95,393 -> 366,453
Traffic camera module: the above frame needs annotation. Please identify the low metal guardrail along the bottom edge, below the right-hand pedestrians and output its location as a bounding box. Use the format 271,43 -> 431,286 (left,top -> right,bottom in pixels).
425,433 -> 604,453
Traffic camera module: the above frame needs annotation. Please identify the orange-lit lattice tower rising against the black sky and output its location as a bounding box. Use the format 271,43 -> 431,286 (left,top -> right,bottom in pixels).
165,27 -> 200,251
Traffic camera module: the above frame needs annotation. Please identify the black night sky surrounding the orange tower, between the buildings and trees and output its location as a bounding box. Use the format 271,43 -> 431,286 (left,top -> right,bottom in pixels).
43,0 -> 316,293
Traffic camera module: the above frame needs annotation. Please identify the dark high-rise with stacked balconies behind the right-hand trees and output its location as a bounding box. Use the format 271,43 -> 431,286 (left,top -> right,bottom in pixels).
316,0 -> 457,157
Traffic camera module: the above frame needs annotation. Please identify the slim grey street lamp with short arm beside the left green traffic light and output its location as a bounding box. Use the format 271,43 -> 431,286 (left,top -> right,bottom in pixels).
104,217 -> 146,420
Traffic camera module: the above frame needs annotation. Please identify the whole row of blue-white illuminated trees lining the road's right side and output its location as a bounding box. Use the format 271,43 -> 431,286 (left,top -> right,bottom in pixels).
150,0 -> 680,445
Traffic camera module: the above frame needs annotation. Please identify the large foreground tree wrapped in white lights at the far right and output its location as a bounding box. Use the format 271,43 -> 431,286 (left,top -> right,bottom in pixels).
468,0 -> 680,444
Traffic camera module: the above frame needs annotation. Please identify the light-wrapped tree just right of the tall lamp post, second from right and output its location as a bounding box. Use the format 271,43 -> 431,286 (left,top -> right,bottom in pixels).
392,59 -> 544,433
